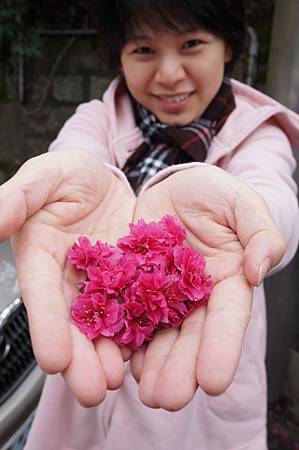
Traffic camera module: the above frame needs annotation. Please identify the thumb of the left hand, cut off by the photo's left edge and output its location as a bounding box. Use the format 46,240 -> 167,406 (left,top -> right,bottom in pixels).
0,153 -> 60,241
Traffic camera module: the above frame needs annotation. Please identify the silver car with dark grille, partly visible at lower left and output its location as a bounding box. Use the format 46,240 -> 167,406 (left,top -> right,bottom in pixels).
0,241 -> 44,450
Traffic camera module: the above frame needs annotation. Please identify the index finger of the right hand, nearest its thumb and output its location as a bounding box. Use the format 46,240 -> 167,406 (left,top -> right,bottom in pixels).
197,275 -> 252,395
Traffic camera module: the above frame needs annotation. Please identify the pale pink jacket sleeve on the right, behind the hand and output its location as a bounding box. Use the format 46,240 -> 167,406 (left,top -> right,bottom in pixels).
221,120 -> 299,272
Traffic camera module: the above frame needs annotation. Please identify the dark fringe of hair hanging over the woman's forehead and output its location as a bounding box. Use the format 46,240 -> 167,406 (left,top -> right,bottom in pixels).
119,0 -> 202,41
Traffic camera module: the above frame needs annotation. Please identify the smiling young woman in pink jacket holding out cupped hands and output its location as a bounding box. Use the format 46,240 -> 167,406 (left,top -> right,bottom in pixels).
0,0 -> 299,450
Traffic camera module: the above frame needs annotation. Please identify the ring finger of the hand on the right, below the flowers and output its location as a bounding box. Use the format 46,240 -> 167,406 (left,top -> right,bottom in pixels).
139,329 -> 178,408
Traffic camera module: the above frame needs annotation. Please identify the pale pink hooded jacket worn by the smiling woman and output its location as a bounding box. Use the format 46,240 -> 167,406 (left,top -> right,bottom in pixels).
25,80 -> 299,450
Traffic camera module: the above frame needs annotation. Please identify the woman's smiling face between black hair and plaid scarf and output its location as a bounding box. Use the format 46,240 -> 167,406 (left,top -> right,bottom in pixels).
121,30 -> 230,126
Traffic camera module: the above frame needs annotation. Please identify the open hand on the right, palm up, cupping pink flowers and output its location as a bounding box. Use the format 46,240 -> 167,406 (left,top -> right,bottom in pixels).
131,166 -> 284,410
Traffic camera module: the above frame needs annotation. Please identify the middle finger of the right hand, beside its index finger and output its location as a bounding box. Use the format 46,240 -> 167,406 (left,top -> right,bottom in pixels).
155,308 -> 206,411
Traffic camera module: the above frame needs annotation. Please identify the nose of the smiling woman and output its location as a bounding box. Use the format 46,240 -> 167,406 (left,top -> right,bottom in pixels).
155,54 -> 186,86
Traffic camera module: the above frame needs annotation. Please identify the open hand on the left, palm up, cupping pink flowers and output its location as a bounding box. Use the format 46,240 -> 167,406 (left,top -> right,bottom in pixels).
0,151 -> 136,405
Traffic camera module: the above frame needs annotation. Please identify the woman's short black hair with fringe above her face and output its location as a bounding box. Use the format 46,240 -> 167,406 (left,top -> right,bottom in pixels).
94,0 -> 246,74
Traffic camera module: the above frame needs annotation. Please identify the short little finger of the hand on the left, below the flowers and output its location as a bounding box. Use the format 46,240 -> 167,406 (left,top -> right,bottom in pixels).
95,336 -> 125,390
